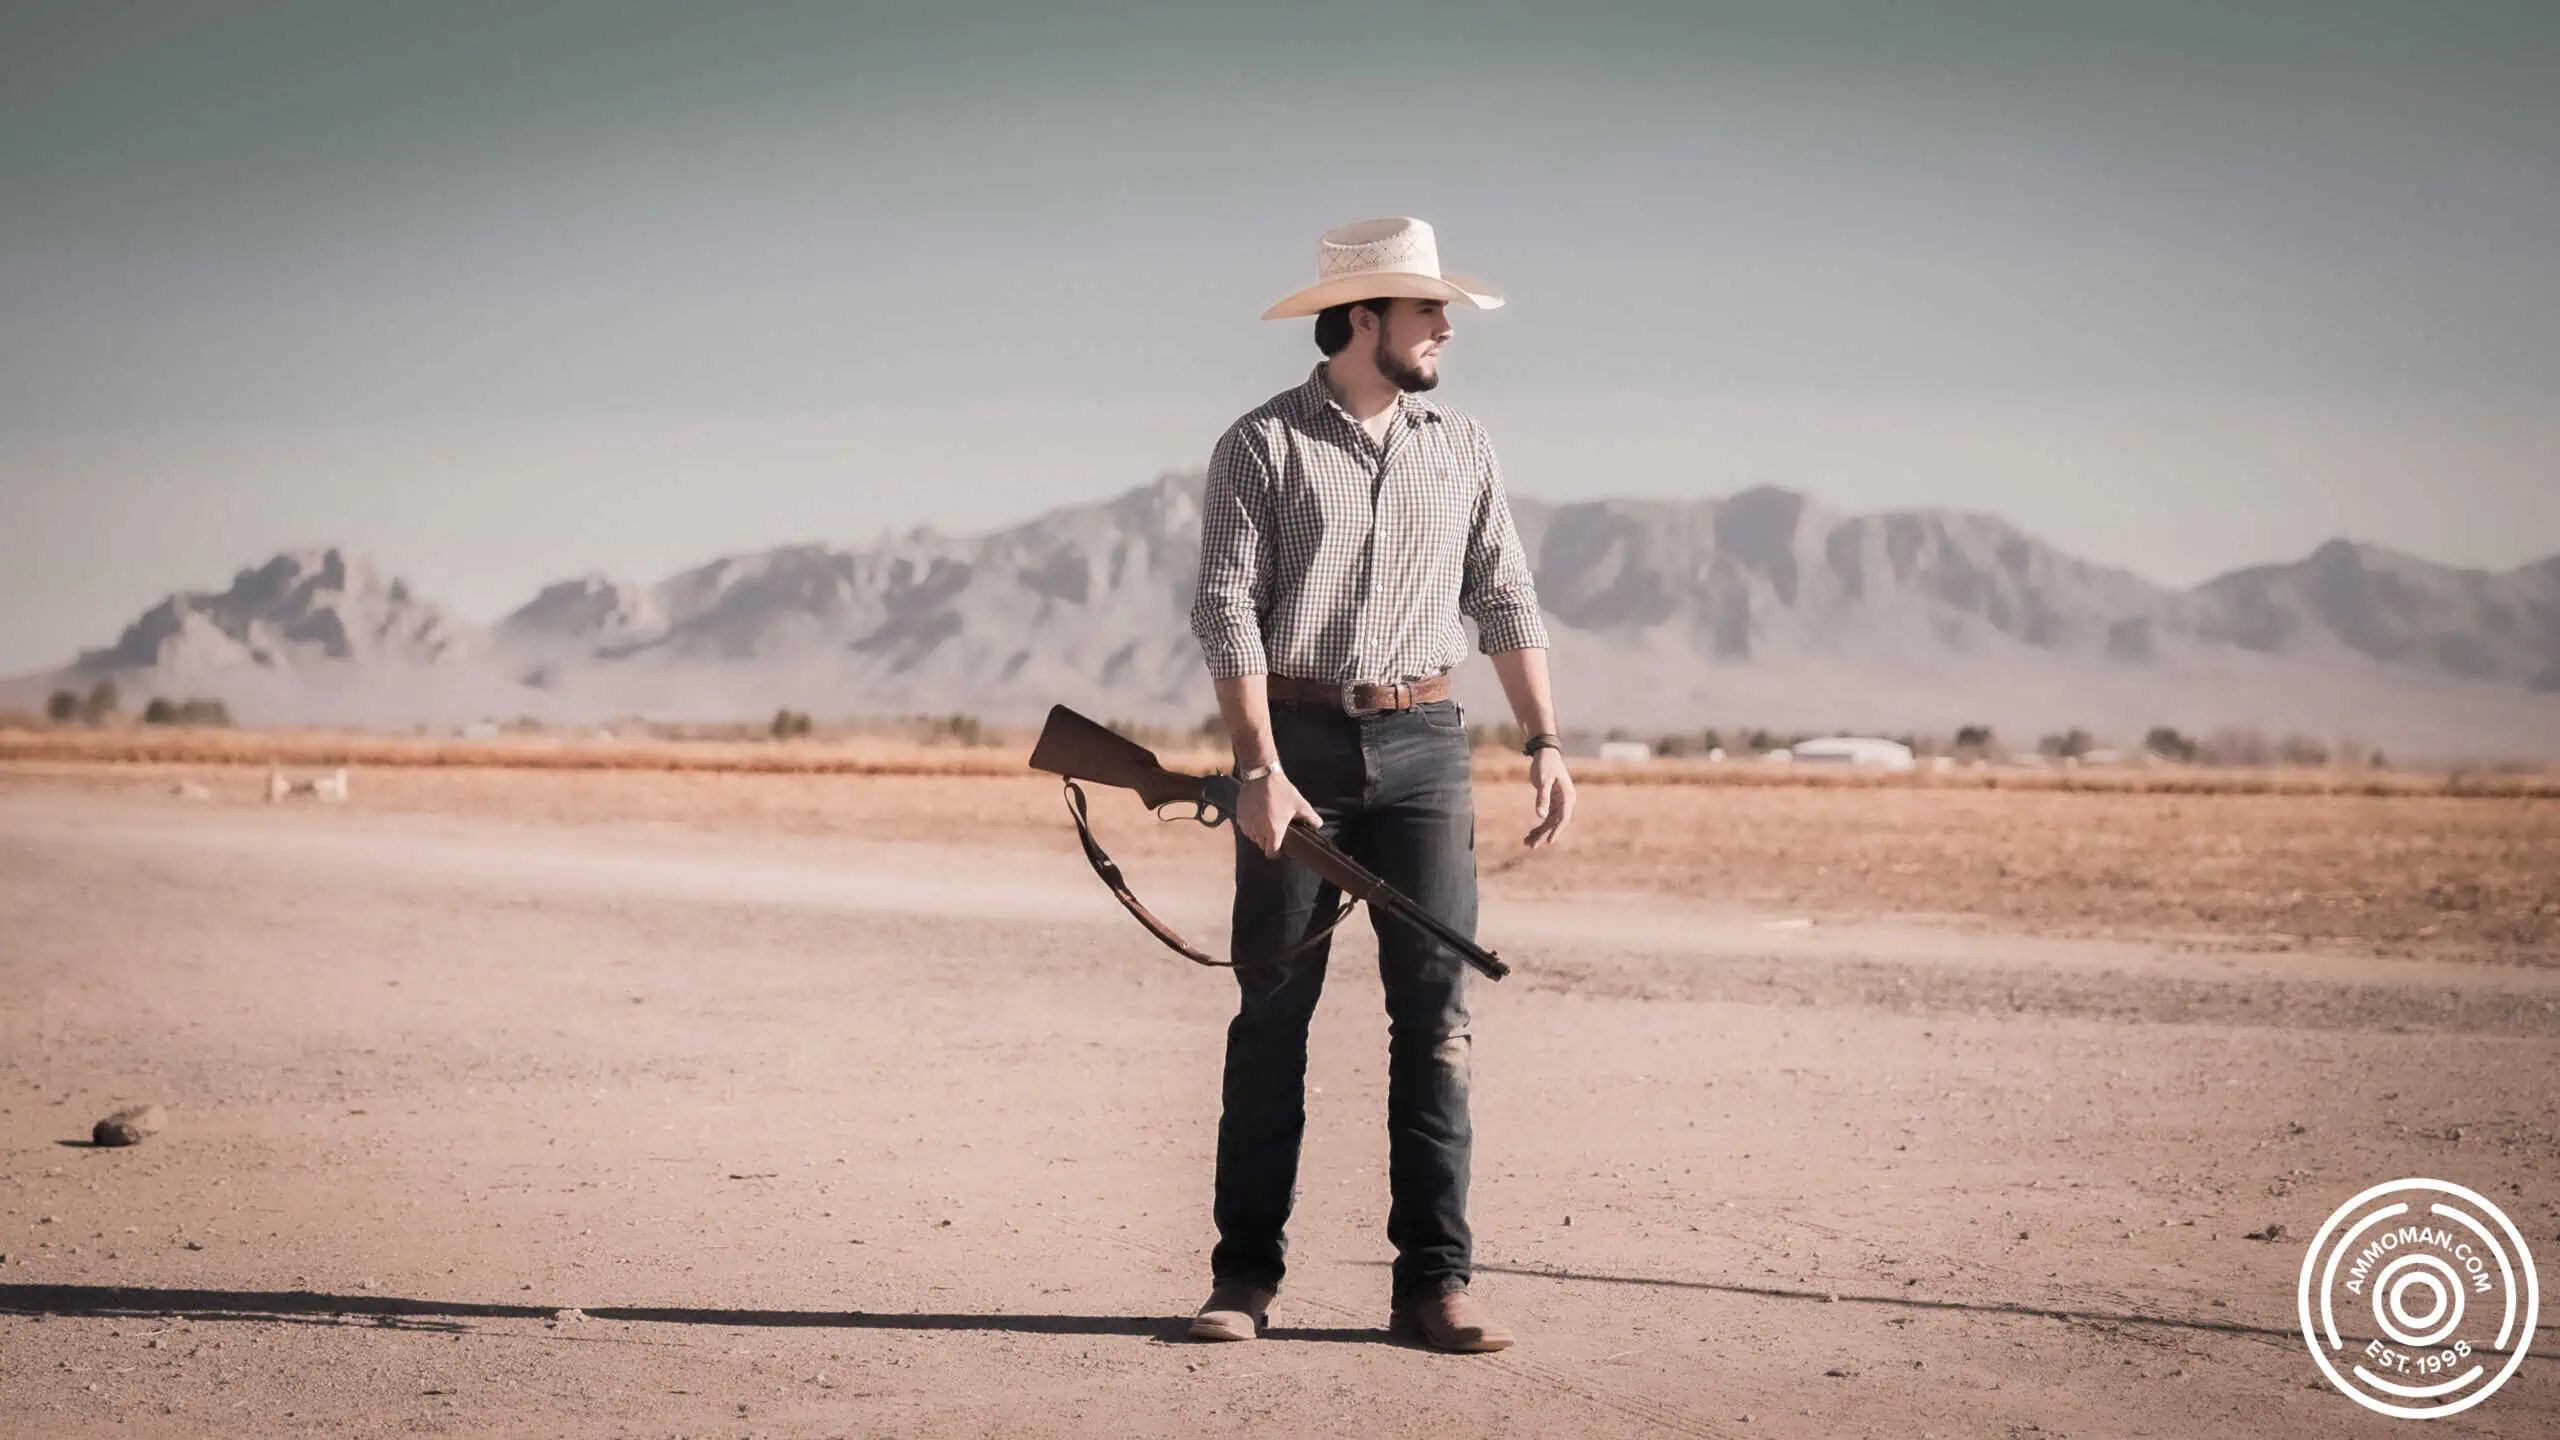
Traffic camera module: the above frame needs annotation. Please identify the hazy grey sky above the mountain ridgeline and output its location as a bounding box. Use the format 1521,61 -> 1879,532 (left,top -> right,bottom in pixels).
0,0 -> 2560,671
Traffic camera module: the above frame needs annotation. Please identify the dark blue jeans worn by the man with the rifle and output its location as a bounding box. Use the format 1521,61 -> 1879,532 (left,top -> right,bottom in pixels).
1208,700 -> 1475,1302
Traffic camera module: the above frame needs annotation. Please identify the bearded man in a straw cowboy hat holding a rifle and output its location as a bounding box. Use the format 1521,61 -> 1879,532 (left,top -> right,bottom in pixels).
1190,218 -> 1574,1350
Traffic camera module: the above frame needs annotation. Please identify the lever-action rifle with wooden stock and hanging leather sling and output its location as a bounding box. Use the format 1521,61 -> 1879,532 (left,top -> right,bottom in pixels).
1032,705 -> 1510,979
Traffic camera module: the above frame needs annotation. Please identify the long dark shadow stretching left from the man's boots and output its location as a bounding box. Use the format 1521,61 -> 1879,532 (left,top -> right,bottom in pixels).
0,1286 -> 1403,1345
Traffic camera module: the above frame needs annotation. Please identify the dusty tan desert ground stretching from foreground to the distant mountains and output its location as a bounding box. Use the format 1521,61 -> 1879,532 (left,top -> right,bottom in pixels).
0,756 -> 2560,1440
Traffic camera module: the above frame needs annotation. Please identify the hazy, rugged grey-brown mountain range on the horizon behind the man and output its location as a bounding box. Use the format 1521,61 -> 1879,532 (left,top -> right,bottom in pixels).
0,474 -> 2560,758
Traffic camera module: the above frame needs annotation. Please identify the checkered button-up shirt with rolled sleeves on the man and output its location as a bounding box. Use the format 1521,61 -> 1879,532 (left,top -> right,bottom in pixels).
1190,364 -> 1546,684
